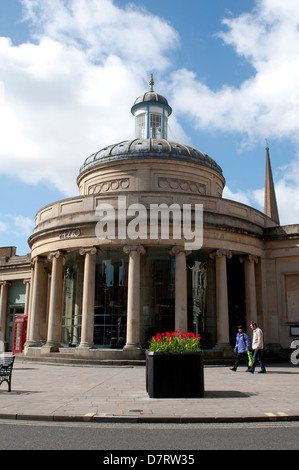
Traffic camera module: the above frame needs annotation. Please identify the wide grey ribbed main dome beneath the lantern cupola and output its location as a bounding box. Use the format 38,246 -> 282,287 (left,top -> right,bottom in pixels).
79,139 -> 222,175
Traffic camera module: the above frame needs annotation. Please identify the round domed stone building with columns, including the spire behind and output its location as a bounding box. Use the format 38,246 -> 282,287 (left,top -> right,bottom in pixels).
0,79 -> 299,360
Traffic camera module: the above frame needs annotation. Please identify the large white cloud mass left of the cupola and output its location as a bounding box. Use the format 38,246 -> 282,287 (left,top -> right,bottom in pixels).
0,0 -> 179,195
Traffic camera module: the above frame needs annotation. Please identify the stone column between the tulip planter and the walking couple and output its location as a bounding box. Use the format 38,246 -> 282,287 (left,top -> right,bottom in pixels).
210,250 -> 232,350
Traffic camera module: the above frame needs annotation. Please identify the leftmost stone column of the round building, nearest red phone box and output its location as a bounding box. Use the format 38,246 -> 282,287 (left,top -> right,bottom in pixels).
25,256 -> 48,348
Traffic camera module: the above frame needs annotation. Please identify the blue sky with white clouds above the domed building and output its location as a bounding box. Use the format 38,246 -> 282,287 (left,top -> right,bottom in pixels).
0,0 -> 299,254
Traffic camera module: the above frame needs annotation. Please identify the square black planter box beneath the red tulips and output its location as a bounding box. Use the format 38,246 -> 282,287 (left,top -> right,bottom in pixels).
146,351 -> 204,398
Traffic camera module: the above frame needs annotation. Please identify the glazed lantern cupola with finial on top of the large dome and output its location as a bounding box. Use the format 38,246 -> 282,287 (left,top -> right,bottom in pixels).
131,74 -> 172,140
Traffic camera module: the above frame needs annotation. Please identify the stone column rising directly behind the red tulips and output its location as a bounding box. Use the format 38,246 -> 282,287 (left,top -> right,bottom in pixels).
170,246 -> 191,333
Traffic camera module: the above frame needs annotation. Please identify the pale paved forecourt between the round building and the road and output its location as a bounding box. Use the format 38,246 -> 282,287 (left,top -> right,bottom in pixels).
0,360 -> 299,423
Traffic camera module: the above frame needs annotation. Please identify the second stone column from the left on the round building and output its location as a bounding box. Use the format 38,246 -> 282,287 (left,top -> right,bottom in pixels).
43,251 -> 66,354
